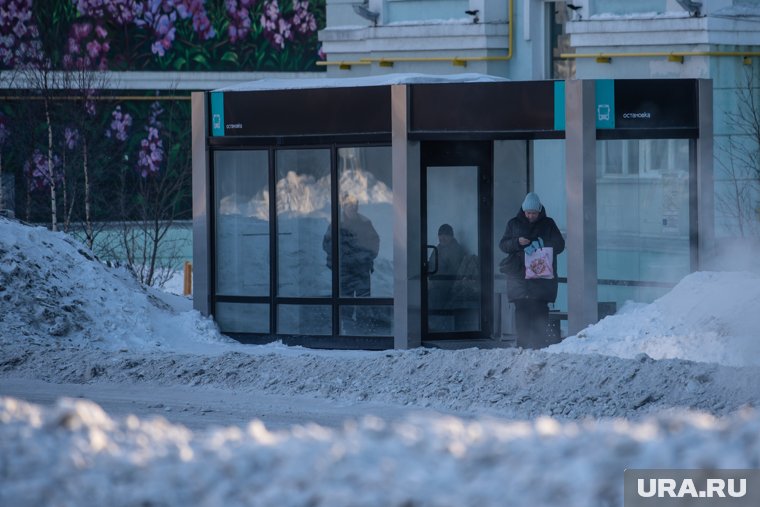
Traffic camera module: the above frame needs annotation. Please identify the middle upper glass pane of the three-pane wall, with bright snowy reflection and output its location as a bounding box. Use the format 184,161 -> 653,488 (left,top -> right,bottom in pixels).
275,149 -> 332,297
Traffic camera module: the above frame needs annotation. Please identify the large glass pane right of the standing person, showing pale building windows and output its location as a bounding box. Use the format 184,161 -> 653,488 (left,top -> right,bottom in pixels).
597,139 -> 690,308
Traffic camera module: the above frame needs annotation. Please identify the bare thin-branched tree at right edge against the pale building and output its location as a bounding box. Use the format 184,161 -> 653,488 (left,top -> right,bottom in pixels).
716,67 -> 760,239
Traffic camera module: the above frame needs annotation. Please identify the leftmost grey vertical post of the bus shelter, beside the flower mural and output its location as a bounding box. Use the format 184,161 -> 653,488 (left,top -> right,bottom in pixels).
191,92 -> 212,315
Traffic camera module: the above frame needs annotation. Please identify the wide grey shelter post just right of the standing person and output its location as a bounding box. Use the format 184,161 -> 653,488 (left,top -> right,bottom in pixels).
565,80 -> 598,335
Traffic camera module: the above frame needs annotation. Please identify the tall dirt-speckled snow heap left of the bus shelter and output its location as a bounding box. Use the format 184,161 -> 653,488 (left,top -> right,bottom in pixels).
0,218 -> 232,350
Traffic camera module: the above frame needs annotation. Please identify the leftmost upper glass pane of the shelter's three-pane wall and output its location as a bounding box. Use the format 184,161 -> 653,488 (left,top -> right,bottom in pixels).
214,151 -> 269,296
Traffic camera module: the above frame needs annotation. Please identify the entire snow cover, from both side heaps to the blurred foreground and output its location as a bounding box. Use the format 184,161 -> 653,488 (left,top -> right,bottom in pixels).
0,219 -> 760,506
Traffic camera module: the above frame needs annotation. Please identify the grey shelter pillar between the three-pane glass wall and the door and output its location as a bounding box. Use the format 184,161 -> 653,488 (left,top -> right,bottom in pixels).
391,85 -> 422,349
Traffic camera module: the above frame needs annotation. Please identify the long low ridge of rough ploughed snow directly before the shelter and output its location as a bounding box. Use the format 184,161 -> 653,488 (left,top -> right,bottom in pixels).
0,345 -> 760,420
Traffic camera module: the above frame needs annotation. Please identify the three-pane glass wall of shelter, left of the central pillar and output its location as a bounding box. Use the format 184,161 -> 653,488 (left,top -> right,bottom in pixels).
214,146 -> 393,342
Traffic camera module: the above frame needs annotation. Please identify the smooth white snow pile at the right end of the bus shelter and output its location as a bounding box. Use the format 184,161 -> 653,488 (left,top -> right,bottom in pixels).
547,272 -> 760,366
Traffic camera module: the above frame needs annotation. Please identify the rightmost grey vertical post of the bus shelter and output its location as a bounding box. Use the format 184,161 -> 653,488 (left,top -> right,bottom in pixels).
689,79 -> 715,271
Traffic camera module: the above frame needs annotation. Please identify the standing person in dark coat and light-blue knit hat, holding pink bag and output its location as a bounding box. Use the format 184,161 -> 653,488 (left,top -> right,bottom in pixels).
499,192 -> 565,349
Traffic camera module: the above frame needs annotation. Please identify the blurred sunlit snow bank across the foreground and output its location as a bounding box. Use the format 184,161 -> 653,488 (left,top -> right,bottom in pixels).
0,398 -> 760,507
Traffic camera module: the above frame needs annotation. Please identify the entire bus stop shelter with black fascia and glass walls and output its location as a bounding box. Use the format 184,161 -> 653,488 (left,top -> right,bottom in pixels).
192,74 -> 713,349
